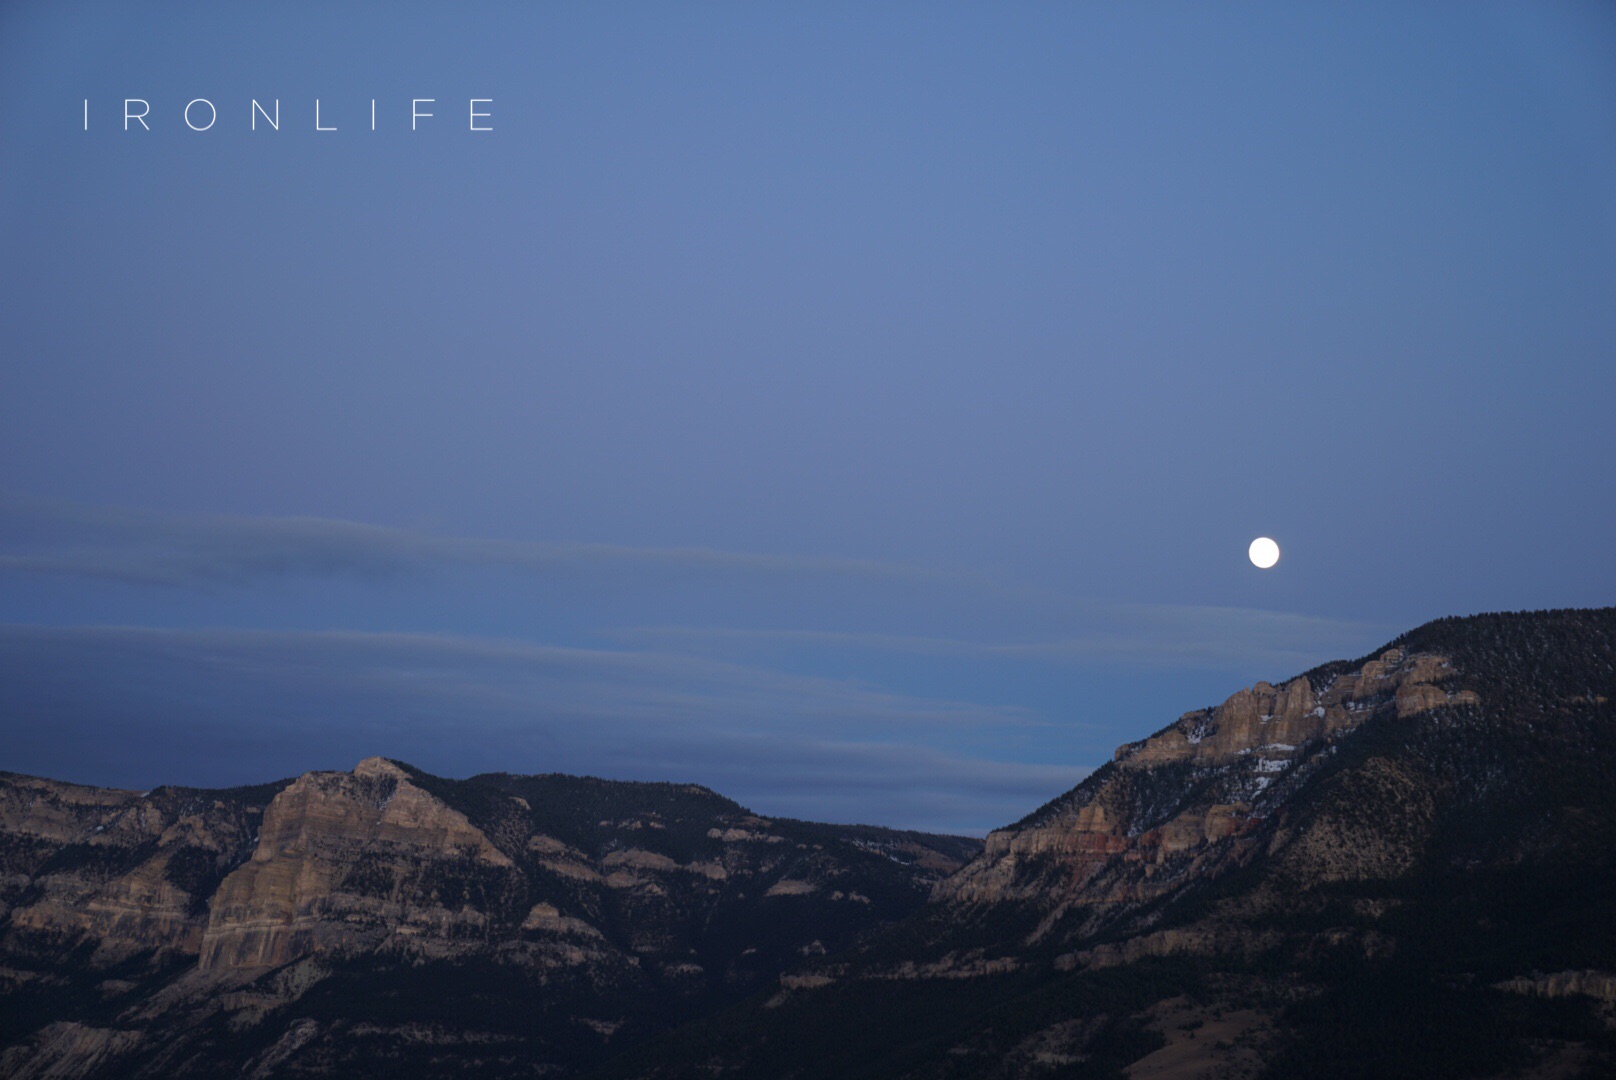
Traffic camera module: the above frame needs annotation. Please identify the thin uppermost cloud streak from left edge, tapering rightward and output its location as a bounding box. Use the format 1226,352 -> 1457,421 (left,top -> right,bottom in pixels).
0,495 -> 939,587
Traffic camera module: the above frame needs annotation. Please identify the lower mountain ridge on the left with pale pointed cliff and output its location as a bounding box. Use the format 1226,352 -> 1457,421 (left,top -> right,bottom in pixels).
0,758 -> 979,1077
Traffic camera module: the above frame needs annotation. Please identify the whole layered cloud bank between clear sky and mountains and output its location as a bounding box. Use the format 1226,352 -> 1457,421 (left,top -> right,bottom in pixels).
0,498 -> 1390,831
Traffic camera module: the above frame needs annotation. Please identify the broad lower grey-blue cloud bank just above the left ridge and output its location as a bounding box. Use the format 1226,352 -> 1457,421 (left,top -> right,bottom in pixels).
0,626 -> 1088,831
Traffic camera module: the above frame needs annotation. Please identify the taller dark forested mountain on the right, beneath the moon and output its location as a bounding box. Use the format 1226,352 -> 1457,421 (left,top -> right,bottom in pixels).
603,610 -> 1616,1080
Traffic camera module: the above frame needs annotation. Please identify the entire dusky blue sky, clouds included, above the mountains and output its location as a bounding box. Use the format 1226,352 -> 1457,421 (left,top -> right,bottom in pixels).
0,3 -> 1616,831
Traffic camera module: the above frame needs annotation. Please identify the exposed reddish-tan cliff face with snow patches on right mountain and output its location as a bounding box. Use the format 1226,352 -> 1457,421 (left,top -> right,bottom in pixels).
932,648 -> 1480,941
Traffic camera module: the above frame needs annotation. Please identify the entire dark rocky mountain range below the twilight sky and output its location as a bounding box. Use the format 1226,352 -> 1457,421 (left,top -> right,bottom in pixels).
0,608 -> 1616,1080
